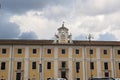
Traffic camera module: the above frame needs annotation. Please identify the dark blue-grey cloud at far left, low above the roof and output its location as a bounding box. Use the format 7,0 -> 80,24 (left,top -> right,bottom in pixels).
0,14 -> 37,39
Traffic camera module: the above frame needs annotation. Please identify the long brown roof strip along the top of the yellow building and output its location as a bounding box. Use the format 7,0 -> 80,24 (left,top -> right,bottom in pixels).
0,40 -> 120,46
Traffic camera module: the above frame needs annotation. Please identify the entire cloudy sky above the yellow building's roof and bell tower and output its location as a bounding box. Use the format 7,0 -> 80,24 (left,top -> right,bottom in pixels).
0,0 -> 120,41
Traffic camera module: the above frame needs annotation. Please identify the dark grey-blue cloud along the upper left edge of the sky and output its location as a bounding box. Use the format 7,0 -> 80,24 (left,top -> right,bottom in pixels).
1,0 -> 69,14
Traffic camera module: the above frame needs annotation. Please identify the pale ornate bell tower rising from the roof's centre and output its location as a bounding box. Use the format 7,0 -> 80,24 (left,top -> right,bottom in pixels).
54,22 -> 72,44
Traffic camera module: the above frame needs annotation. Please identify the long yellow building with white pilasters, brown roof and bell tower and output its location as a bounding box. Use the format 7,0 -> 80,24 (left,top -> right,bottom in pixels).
0,24 -> 120,80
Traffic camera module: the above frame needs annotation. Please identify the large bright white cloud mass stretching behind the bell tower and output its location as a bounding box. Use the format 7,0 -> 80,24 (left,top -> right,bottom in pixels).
8,0 -> 120,40
